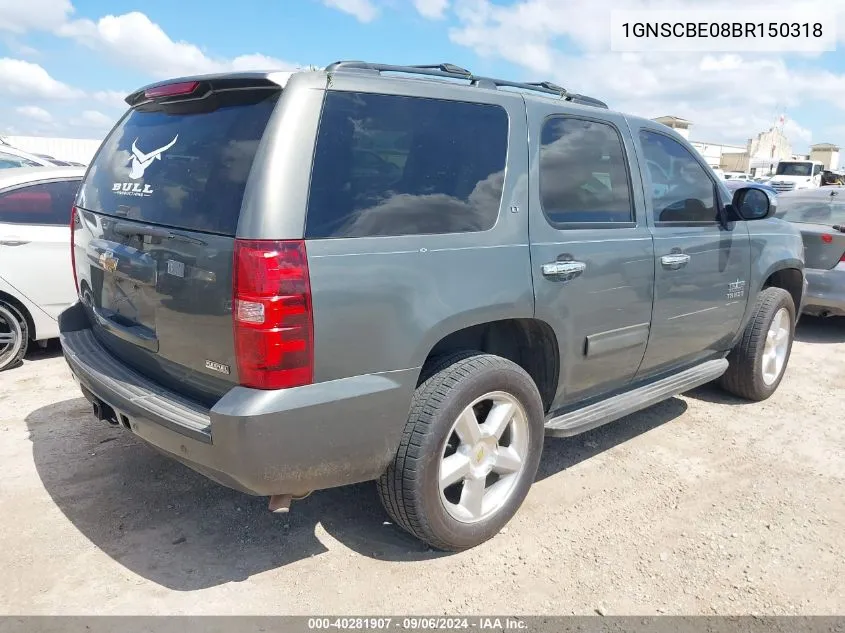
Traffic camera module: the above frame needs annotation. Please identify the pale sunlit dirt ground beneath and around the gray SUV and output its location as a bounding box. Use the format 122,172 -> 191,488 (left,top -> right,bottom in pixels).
0,318 -> 845,615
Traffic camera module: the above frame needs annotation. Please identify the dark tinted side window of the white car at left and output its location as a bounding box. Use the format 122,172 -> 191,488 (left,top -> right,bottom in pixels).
0,180 -> 79,225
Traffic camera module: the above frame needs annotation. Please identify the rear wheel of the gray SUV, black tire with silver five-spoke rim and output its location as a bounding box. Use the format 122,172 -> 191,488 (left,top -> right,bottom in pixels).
378,352 -> 545,551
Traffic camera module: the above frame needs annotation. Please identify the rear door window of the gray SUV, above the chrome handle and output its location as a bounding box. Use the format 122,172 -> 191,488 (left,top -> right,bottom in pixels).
540,117 -> 634,225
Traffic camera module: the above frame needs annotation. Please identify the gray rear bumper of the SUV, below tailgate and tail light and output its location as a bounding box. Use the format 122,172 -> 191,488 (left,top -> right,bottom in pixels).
59,304 -> 419,495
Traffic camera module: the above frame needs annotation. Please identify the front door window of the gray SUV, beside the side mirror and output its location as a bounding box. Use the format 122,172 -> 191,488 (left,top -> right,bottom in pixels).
640,130 -> 718,223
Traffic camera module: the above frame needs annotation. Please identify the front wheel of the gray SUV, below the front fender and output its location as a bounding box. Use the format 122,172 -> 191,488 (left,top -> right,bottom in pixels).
719,288 -> 796,402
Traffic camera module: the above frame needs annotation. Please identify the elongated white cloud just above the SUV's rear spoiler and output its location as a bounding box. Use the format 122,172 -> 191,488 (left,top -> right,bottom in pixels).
58,11 -> 292,79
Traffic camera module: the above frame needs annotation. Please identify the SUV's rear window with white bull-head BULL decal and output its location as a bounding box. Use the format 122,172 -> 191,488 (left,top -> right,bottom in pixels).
79,90 -> 279,235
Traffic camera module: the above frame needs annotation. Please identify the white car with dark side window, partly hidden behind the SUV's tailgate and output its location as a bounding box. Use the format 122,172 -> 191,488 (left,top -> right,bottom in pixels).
0,165 -> 85,371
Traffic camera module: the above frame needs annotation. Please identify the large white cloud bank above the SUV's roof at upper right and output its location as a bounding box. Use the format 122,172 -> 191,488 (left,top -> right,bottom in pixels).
450,0 -> 845,146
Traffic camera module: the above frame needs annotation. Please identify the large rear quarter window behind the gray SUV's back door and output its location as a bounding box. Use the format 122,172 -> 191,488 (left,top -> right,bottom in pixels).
305,92 -> 508,238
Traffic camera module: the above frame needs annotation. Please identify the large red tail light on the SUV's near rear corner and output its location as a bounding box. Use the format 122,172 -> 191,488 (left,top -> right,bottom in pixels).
232,240 -> 314,389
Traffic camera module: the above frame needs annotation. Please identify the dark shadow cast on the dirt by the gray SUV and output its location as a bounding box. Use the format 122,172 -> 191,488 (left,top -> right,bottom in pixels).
26,398 -> 686,591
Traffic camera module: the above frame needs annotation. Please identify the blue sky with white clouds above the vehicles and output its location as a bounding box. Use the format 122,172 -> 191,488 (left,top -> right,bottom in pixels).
0,0 -> 845,152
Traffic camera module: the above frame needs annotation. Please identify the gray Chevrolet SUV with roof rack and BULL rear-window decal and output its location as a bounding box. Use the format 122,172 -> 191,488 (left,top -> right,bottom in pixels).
60,62 -> 805,550
